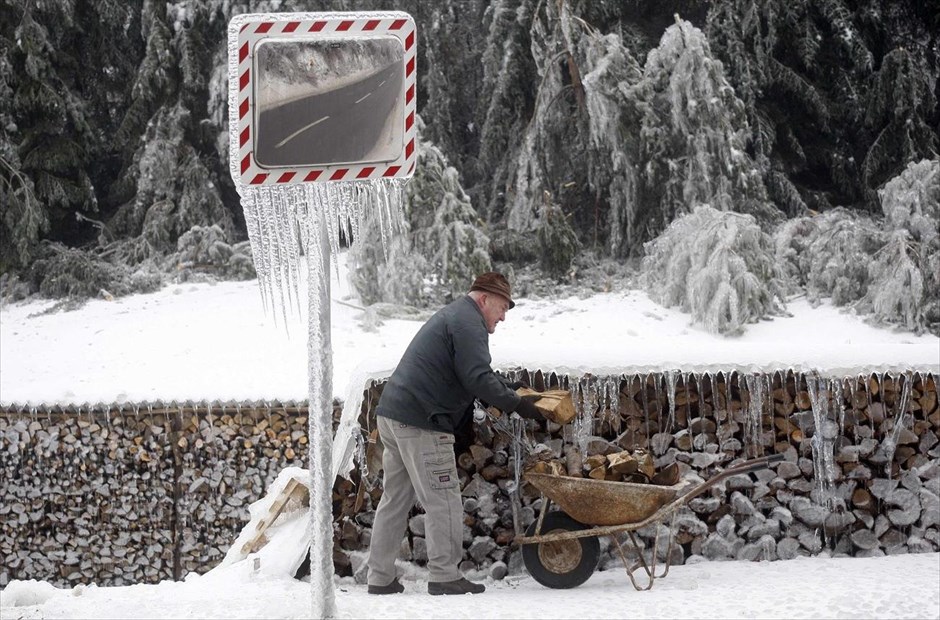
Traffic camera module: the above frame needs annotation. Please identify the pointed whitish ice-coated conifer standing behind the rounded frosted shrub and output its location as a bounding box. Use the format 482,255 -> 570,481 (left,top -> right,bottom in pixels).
641,18 -> 780,240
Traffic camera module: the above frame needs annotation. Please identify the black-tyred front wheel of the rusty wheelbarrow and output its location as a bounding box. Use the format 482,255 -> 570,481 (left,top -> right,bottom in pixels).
522,511 -> 600,589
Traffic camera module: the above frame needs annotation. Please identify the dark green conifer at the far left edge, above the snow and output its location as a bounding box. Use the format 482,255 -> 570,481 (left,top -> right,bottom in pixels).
0,2 -> 102,271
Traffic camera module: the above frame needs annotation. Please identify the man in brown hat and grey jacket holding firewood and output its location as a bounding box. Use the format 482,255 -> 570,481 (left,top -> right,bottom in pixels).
369,272 -> 541,594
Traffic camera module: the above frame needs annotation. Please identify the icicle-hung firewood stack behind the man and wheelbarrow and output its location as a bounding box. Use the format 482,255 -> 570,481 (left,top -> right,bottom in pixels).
337,371 -> 940,580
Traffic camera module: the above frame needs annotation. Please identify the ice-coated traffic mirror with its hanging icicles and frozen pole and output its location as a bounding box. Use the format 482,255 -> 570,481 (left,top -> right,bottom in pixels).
228,12 -> 416,618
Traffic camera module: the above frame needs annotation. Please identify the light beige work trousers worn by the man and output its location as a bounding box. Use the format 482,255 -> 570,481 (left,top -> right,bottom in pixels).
369,416 -> 463,586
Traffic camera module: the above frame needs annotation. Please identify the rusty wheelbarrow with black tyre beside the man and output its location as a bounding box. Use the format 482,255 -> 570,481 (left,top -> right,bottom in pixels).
514,454 -> 784,590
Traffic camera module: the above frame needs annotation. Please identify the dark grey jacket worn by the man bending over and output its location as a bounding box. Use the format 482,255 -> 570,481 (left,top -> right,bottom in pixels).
375,295 -> 519,433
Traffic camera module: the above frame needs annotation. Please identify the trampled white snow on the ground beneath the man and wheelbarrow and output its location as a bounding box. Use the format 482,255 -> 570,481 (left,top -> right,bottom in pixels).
0,554 -> 940,620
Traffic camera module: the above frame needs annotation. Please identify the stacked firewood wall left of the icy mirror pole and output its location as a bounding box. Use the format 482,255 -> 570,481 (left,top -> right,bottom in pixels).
0,403 -> 339,587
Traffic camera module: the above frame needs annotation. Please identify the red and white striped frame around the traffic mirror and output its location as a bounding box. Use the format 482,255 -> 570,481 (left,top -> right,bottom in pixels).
229,12 -> 417,187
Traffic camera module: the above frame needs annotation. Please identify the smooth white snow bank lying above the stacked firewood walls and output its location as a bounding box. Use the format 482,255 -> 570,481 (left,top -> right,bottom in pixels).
0,252 -> 940,405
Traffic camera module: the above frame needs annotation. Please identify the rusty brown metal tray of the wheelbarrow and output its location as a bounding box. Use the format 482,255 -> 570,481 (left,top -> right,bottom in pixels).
525,472 -> 691,525
